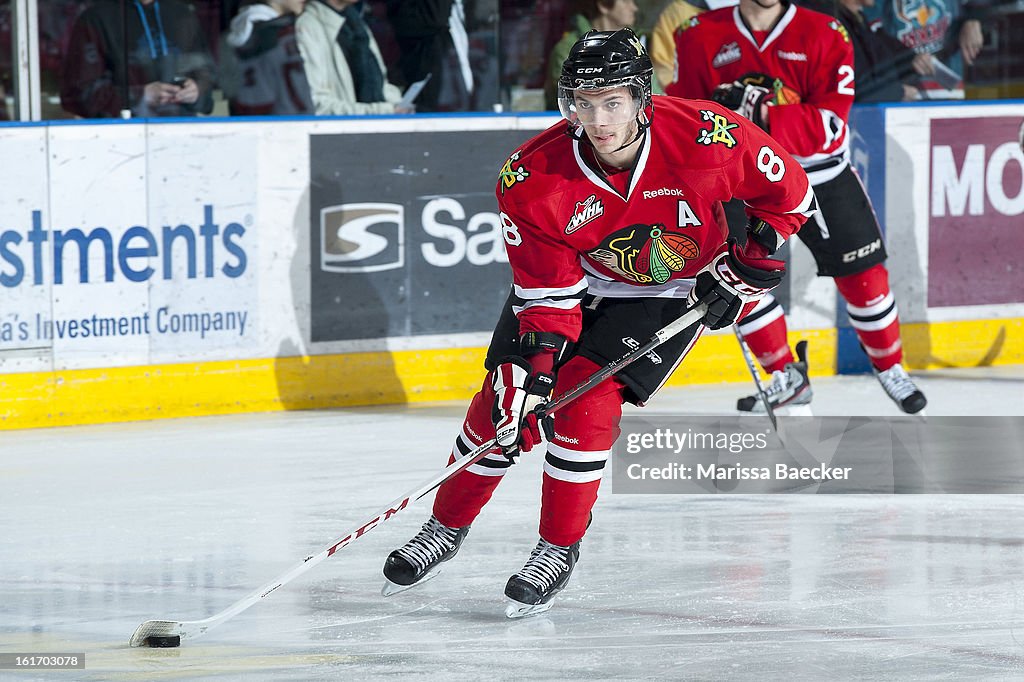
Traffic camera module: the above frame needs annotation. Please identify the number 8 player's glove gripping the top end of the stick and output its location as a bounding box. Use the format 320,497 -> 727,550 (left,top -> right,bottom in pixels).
687,238 -> 785,329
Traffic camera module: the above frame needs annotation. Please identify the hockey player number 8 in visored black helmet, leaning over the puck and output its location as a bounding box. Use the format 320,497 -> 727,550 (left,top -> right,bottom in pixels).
384,29 -> 814,617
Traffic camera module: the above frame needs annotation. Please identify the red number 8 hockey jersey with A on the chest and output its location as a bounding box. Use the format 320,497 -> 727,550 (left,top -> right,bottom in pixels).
496,96 -> 813,341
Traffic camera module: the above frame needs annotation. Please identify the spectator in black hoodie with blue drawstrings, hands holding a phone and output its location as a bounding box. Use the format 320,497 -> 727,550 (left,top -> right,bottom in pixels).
60,0 -> 214,118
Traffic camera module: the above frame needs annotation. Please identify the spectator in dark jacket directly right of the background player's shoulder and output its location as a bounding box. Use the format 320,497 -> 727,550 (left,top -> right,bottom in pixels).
800,0 -> 935,102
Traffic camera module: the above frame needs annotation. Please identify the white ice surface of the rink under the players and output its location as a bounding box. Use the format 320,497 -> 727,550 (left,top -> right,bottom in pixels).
0,368 -> 1024,680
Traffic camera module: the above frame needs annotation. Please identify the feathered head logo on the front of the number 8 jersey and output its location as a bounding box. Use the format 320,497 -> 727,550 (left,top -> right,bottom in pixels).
588,223 -> 700,285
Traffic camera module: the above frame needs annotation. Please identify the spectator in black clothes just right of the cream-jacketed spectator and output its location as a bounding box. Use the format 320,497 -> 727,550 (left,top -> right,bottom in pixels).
387,0 -> 474,112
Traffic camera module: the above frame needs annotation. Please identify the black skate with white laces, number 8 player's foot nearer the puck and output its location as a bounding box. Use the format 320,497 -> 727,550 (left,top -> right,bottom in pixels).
381,516 -> 469,597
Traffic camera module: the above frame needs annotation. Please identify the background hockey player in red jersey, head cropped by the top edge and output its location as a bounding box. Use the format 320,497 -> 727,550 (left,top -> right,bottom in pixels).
666,0 -> 927,414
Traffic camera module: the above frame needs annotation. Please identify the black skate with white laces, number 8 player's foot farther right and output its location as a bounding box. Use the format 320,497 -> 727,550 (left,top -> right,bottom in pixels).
505,538 -> 580,619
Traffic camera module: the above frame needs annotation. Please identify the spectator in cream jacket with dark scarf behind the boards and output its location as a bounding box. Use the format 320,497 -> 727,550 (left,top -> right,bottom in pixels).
295,0 -> 413,115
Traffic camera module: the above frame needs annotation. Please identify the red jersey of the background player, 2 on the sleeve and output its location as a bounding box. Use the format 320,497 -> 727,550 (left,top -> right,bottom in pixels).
666,5 -> 854,184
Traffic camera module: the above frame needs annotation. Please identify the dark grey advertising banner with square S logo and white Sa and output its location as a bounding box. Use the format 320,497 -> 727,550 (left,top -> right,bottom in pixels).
309,130 -> 534,342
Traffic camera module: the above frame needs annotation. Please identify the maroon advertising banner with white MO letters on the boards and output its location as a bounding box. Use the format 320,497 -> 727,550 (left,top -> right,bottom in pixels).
928,116 -> 1024,307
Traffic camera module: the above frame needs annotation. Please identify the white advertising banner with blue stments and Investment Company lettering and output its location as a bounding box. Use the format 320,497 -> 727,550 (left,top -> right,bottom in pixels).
0,126 -> 258,369
